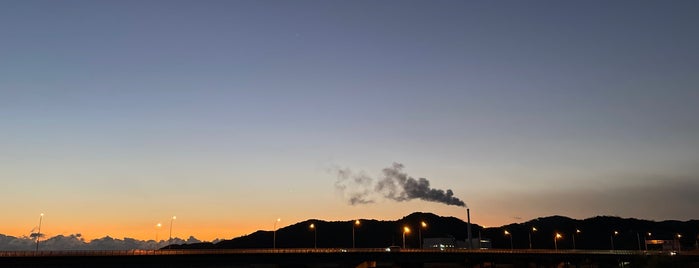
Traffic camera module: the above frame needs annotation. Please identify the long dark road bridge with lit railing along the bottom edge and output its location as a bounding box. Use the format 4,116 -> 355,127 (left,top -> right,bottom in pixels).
0,248 -> 699,268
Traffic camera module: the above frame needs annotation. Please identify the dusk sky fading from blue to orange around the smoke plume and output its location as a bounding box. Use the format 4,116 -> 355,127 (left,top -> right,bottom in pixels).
0,0 -> 699,240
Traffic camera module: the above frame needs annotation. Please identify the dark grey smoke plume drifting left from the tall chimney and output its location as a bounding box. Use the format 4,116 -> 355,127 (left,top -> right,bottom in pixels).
335,163 -> 466,207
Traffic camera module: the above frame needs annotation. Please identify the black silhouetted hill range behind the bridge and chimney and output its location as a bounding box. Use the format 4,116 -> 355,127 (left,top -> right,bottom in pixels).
172,212 -> 699,250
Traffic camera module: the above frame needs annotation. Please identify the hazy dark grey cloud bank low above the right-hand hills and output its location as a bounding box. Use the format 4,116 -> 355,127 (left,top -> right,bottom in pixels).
489,176 -> 699,220
